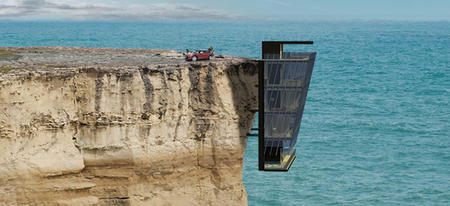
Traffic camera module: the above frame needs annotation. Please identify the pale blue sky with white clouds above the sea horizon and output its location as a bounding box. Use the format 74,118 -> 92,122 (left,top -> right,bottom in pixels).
0,0 -> 450,21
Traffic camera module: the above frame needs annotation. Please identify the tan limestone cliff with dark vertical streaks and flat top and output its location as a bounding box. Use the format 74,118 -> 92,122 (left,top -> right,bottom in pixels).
0,48 -> 257,205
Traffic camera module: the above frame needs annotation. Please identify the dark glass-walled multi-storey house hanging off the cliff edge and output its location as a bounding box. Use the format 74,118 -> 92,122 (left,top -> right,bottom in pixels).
258,41 -> 316,171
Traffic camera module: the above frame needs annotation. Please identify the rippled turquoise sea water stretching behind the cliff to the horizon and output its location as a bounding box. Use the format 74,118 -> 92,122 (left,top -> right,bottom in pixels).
0,21 -> 450,205
